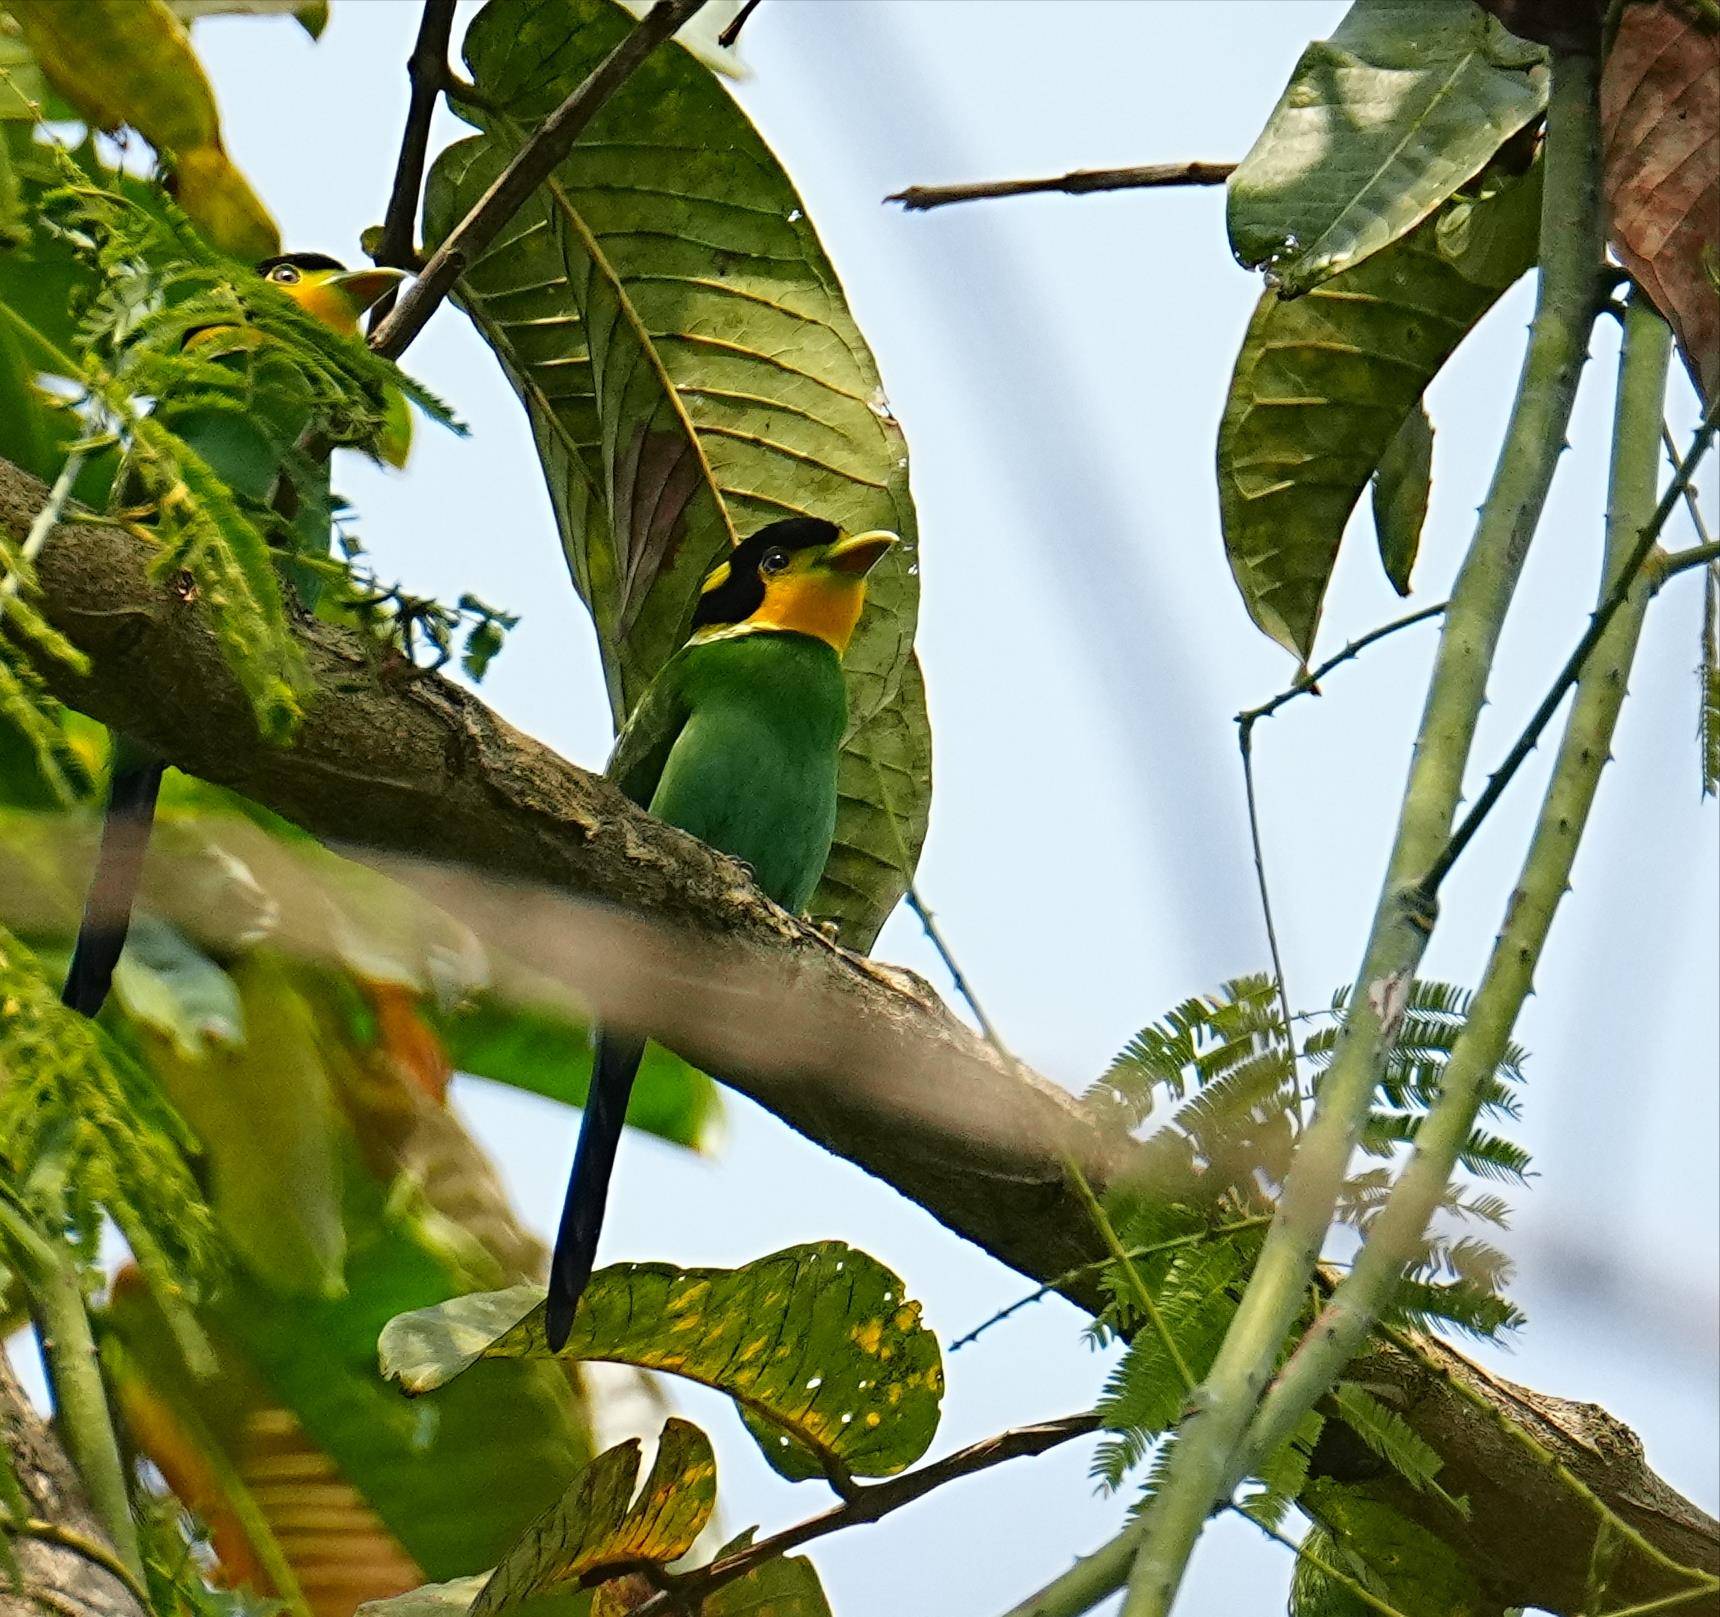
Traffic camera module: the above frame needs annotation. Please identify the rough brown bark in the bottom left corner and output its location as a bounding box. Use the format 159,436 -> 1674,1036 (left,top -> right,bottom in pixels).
0,1352 -> 144,1617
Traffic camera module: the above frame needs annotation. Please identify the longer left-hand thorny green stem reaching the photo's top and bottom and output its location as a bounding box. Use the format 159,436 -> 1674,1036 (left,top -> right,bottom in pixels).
1087,52 -> 1603,1617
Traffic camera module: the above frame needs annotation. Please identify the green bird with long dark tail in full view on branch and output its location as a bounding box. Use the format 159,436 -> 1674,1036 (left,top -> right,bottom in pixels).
545,516 -> 896,1349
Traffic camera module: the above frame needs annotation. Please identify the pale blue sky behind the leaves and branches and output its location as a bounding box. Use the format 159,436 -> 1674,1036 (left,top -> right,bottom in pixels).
167,0 -> 1720,1617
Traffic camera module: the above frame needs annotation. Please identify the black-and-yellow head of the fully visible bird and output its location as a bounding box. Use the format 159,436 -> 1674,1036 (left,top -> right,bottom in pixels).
693,516 -> 896,655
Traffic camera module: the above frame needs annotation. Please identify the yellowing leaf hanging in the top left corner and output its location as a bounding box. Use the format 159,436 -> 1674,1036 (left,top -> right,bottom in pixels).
7,0 -> 280,260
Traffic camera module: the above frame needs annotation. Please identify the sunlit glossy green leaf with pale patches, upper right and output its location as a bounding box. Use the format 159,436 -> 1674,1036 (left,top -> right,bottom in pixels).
1228,0 -> 1546,296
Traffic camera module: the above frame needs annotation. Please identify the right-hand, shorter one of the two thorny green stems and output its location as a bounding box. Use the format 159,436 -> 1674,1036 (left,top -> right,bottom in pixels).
1230,294 -> 1692,1527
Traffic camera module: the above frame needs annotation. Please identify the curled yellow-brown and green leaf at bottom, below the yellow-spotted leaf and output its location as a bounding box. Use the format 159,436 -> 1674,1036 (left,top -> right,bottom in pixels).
471,1417 -> 717,1617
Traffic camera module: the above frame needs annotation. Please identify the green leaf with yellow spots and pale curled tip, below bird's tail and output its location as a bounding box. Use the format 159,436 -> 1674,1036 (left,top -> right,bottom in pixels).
380,1240 -> 944,1476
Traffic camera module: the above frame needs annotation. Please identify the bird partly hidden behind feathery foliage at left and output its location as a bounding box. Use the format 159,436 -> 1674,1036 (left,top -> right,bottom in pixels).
60,253 -> 404,1017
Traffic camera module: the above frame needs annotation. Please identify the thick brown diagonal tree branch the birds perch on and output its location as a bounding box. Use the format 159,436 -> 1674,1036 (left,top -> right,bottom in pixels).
0,461 -> 1720,1612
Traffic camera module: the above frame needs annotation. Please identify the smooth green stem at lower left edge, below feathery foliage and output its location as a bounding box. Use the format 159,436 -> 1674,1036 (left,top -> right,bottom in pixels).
0,1197 -> 143,1583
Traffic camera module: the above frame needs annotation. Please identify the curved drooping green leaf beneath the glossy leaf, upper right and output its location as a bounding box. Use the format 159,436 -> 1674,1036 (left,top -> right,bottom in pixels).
1218,151 -> 1541,659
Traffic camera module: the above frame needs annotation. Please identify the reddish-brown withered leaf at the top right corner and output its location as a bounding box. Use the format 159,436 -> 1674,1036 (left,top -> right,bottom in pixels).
1601,0 -> 1720,403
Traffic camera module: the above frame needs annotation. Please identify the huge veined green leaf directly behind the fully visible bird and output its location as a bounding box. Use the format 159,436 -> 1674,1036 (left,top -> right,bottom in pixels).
425,0 -> 931,948
